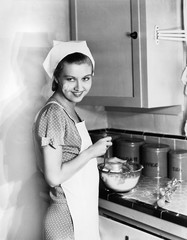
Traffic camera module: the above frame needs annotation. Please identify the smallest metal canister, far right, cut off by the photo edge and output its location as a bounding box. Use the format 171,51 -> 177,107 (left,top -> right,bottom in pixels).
168,149 -> 187,180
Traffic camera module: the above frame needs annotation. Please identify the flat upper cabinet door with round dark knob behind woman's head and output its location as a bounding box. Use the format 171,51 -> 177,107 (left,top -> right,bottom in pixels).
71,0 -> 141,106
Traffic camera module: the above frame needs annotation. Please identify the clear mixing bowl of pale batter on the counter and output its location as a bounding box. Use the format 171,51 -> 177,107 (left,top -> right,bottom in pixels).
98,162 -> 143,192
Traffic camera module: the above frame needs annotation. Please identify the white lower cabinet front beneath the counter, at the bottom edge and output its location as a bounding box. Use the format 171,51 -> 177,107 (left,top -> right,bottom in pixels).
100,216 -> 161,240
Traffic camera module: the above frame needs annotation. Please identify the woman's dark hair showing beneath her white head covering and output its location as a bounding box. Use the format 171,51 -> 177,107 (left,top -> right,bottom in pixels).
52,52 -> 93,91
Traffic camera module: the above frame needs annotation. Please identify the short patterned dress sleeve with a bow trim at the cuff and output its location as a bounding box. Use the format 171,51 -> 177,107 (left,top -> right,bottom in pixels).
38,104 -> 66,148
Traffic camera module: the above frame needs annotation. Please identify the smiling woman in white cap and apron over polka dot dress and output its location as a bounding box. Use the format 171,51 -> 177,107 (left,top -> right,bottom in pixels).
34,41 -> 112,240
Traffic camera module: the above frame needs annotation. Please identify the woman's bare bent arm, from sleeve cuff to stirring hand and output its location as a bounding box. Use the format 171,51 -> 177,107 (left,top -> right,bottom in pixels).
43,137 -> 112,187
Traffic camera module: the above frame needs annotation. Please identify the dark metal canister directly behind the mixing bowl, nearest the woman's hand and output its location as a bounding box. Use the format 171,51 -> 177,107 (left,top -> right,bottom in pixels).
113,137 -> 144,163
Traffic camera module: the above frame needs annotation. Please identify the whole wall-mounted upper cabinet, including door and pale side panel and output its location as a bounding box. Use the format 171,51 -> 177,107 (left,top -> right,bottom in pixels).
70,0 -> 184,108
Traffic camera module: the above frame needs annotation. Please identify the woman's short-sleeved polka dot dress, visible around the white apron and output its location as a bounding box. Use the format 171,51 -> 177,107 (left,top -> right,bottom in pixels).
35,100 -> 81,240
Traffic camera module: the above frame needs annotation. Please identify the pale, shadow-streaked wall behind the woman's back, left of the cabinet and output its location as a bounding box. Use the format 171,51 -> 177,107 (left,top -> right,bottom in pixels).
0,0 -> 69,240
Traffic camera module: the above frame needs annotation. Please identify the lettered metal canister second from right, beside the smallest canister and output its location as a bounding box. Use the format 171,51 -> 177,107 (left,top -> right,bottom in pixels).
142,143 -> 170,177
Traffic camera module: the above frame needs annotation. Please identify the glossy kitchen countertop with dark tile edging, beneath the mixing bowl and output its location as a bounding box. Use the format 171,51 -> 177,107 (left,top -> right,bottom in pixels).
100,176 -> 187,239
